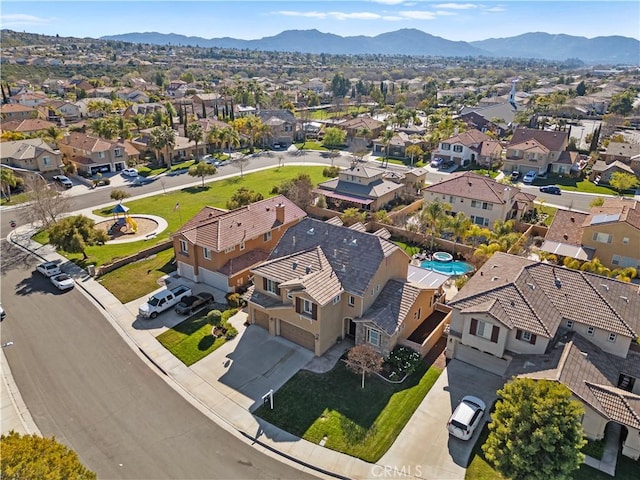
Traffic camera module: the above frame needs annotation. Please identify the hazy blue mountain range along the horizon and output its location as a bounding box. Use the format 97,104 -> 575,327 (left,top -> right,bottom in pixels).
101,29 -> 640,65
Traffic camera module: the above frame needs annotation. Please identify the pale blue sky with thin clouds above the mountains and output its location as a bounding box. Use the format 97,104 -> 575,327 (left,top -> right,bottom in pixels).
0,0 -> 640,42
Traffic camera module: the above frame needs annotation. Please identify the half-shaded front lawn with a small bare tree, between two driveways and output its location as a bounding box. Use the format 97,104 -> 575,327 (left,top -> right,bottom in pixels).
255,362 -> 441,462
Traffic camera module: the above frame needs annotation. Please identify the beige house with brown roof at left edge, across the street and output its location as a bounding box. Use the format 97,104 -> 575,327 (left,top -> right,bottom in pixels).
0,138 -> 62,174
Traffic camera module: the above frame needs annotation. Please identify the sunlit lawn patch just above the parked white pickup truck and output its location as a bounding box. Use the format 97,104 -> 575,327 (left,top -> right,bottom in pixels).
98,248 -> 176,303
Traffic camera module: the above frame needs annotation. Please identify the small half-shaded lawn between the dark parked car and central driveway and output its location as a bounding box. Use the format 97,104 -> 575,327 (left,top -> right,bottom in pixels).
156,310 -> 227,367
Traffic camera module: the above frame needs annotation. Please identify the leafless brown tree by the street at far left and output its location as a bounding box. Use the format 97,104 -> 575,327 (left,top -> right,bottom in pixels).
24,175 -> 70,229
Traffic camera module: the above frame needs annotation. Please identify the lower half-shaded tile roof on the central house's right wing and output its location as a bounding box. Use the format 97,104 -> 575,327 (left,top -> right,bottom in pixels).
359,280 -> 425,335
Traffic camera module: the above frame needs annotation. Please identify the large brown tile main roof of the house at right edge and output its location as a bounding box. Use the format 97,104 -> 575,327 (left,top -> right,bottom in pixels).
449,253 -> 640,338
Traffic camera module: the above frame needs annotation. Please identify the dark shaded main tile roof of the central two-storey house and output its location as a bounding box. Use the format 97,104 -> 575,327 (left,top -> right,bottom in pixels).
262,218 -> 402,295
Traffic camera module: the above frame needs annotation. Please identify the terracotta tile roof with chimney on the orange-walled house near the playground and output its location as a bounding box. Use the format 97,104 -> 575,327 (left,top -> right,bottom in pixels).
178,195 -> 307,252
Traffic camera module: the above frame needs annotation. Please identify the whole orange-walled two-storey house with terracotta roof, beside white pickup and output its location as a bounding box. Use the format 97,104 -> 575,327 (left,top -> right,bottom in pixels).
173,195 -> 306,292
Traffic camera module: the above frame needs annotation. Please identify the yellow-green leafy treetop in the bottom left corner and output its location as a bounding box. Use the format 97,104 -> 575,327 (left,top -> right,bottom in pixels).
0,431 -> 97,480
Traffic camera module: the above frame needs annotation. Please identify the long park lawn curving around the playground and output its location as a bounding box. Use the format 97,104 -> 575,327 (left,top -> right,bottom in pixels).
33,166 -> 326,266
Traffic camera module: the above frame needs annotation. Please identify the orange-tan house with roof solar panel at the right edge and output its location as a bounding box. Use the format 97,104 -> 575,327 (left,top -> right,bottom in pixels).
541,198 -> 640,270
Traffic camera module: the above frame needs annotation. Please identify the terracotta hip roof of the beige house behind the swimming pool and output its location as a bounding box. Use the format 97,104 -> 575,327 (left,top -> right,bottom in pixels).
422,172 -> 524,204
